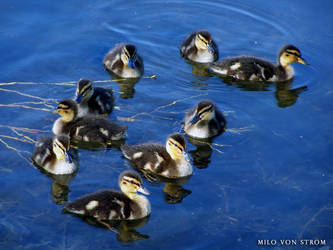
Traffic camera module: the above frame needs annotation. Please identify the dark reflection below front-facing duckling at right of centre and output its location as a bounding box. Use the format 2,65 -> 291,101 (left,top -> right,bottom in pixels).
187,136 -> 213,169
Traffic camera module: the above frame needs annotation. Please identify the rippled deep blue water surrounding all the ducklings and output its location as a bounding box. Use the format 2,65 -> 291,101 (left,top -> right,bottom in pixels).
0,0 -> 333,249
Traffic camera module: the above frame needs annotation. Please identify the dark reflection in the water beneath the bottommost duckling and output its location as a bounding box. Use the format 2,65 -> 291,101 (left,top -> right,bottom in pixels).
77,215 -> 150,242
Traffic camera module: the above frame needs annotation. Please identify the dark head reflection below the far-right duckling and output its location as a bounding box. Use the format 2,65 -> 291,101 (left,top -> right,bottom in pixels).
275,81 -> 307,108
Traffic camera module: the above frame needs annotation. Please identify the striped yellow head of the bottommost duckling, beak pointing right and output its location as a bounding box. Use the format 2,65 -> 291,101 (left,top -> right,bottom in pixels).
119,171 -> 150,198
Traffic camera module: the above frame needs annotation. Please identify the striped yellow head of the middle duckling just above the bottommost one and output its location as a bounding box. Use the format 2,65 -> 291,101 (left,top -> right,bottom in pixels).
166,133 -> 188,160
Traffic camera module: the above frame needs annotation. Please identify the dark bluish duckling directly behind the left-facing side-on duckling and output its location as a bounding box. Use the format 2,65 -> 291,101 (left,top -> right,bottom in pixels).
75,78 -> 114,117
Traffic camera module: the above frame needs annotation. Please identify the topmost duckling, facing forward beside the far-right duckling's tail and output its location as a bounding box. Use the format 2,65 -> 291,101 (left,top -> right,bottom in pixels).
180,30 -> 219,63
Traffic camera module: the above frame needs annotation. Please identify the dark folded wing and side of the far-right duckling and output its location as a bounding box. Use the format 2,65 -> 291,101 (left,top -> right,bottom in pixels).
211,56 -> 275,81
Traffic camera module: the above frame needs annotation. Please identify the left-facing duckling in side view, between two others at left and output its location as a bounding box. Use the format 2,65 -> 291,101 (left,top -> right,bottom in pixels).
52,99 -> 127,144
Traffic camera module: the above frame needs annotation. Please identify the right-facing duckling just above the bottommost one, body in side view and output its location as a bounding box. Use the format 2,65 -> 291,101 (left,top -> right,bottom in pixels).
121,133 -> 193,178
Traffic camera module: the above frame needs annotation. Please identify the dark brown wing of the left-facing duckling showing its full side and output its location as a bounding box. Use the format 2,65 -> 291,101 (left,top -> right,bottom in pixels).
71,116 -> 127,143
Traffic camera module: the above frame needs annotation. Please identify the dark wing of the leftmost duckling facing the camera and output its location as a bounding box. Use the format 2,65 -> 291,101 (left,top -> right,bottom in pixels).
31,136 -> 54,166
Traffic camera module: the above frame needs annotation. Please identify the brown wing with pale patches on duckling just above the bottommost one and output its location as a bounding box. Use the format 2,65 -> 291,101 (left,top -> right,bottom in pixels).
121,143 -> 173,174
